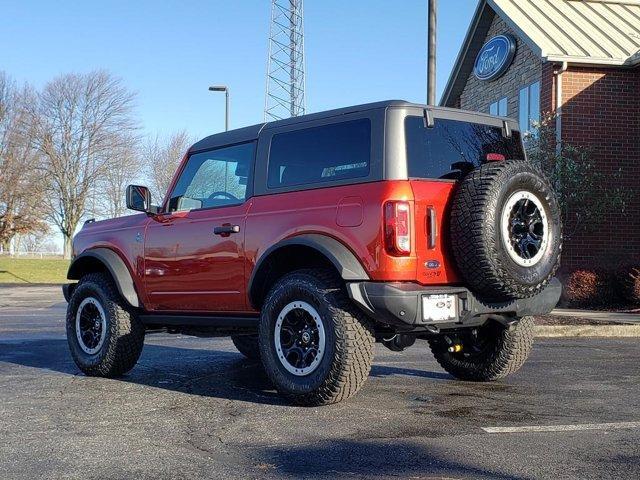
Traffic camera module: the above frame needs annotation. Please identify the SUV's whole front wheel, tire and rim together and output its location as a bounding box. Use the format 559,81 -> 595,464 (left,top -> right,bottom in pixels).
66,273 -> 145,378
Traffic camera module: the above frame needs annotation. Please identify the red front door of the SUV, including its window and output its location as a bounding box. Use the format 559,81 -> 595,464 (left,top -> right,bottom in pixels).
145,142 -> 255,313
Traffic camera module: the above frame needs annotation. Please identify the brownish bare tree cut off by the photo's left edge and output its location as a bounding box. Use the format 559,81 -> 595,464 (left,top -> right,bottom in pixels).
0,72 -> 48,251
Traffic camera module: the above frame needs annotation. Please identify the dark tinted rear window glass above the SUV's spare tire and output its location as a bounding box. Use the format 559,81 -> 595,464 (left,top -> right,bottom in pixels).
405,116 -> 524,180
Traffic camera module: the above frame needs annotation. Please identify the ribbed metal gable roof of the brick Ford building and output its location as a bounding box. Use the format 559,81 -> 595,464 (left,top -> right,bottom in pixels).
440,0 -> 640,106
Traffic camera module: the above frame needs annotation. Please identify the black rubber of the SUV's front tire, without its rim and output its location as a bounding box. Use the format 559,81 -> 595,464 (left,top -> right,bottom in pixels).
66,273 -> 145,378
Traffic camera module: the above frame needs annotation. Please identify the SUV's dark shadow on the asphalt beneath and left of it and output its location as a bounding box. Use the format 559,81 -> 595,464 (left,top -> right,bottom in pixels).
0,339 -> 452,405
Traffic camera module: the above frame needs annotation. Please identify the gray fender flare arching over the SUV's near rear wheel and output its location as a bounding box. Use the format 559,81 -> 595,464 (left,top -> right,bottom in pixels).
247,233 -> 370,304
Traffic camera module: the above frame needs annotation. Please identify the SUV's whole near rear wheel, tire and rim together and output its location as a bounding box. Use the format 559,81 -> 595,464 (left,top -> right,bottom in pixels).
259,269 -> 374,406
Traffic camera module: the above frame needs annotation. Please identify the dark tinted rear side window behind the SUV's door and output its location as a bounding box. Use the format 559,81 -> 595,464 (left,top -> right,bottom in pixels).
268,119 -> 371,188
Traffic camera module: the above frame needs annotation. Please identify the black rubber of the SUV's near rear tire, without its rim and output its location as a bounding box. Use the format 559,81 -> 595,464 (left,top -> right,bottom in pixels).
259,269 -> 375,406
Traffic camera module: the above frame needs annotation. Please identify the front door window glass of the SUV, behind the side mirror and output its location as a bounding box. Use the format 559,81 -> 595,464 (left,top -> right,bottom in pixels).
169,142 -> 255,212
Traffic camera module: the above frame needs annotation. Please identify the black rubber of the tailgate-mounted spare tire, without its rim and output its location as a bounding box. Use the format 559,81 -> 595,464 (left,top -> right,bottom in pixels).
450,160 -> 562,300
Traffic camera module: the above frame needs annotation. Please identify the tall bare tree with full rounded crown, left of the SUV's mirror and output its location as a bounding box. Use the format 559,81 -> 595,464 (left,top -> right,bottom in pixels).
23,71 -> 137,258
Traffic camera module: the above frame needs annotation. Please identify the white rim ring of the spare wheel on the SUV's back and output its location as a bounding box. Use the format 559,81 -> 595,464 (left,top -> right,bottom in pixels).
500,190 -> 550,267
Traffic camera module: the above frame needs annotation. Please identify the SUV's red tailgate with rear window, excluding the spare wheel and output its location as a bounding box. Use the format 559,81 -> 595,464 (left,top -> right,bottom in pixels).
405,116 -> 525,284
